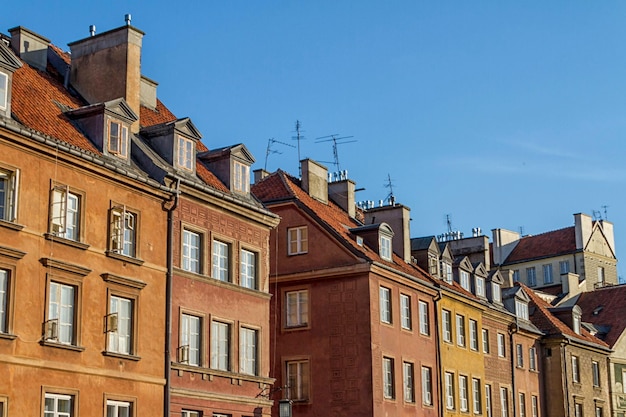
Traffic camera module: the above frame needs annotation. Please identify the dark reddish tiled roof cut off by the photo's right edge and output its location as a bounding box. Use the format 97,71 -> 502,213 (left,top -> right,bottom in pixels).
576,284 -> 626,347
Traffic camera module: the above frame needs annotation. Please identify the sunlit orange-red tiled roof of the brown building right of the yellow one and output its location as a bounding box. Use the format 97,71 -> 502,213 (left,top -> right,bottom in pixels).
515,282 -> 608,347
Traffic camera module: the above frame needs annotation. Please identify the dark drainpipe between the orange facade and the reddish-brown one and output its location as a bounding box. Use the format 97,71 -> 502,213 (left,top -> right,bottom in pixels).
163,179 -> 180,417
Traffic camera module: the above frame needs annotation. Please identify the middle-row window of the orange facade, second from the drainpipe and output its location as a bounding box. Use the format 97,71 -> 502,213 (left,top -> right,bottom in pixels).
45,282 -> 76,345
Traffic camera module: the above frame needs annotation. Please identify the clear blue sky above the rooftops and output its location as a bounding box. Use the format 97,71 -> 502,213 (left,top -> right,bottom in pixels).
0,0 -> 626,280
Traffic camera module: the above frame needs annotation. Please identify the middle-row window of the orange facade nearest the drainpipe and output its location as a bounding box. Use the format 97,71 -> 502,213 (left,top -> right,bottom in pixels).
107,295 -> 134,355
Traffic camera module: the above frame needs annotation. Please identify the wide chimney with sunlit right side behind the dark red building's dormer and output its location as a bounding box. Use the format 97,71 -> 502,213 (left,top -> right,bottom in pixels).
365,204 -> 411,263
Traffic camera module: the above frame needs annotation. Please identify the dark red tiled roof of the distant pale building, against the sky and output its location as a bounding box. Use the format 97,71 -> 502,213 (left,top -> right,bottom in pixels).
505,226 -> 576,264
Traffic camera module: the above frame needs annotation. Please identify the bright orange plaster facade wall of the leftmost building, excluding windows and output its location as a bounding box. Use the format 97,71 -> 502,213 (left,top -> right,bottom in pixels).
0,128 -> 167,415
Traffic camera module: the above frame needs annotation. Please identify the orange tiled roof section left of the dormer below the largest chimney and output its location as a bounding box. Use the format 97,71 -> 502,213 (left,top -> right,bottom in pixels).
11,63 -> 100,153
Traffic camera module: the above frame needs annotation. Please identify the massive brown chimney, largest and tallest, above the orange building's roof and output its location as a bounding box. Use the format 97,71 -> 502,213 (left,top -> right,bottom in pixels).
69,25 -> 144,133
